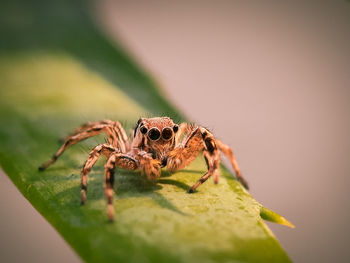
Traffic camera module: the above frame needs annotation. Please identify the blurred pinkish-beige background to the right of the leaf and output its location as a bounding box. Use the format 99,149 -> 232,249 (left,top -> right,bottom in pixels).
96,0 -> 350,262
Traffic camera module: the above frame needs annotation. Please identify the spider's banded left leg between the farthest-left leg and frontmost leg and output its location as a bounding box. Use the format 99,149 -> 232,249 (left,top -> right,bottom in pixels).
81,144 -> 117,205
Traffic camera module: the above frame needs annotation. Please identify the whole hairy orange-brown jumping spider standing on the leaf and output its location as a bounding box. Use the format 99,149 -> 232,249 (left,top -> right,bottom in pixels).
39,117 -> 248,220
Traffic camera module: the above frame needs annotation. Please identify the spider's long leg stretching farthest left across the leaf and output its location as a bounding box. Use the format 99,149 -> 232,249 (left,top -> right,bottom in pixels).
39,122 -> 129,171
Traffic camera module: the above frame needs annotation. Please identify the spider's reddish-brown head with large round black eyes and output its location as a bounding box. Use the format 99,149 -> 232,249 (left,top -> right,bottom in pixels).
134,117 -> 179,150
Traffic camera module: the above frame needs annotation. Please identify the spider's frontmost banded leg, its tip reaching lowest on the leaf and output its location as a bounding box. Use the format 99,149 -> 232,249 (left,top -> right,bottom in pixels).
105,153 -> 139,221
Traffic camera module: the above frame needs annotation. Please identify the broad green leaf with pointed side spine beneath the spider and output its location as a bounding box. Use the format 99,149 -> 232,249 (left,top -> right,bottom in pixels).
0,1 -> 292,262
